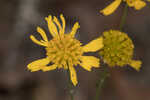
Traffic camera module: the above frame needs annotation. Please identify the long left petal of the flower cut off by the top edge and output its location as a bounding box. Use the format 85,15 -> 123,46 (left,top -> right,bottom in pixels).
100,0 -> 122,16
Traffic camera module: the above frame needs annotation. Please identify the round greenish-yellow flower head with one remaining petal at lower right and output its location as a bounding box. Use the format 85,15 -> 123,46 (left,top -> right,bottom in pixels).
100,30 -> 141,71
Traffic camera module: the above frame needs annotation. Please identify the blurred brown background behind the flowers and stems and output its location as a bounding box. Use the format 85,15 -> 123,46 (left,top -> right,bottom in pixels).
0,0 -> 150,100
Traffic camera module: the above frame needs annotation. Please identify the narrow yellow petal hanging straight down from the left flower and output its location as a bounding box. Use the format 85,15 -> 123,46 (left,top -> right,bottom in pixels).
69,66 -> 78,86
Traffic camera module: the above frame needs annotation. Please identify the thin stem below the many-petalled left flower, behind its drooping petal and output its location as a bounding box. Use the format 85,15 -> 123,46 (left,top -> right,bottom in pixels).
67,70 -> 75,100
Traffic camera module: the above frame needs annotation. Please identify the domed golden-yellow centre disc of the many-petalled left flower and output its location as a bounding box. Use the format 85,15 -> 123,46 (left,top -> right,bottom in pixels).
46,34 -> 83,69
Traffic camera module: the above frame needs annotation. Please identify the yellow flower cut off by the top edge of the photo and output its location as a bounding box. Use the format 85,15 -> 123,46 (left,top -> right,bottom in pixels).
100,0 -> 146,16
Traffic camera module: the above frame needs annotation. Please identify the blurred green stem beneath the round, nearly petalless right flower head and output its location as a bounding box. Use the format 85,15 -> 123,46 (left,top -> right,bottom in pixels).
95,66 -> 109,100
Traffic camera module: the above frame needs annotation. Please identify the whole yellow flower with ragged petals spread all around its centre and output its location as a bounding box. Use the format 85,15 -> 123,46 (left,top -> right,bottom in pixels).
27,14 -> 103,86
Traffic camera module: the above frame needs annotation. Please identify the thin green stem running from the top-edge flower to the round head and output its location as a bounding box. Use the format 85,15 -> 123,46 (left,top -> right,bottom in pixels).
120,3 -> 128,31
